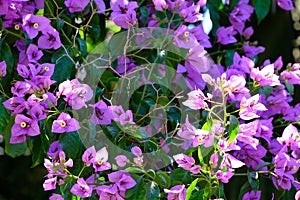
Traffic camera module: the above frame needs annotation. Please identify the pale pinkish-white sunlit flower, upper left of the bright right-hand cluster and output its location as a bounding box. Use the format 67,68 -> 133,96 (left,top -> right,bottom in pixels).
182,89 -> 210,110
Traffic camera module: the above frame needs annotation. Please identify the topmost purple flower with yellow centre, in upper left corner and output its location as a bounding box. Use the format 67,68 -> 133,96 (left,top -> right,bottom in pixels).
22,14 -> 50,39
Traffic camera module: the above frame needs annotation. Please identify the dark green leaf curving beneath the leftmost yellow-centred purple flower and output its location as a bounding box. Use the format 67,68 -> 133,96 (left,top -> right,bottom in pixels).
3,117 -> 27,158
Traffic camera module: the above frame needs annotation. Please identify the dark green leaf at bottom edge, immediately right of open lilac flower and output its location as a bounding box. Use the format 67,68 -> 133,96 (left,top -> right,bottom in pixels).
125,176 -> 146,200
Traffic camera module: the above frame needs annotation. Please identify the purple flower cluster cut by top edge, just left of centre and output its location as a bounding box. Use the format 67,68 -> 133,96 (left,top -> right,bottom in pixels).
110,0 -> 138,29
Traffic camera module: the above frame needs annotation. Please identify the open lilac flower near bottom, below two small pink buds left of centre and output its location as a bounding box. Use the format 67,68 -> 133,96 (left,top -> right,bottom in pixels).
108,170 -> 136,191
